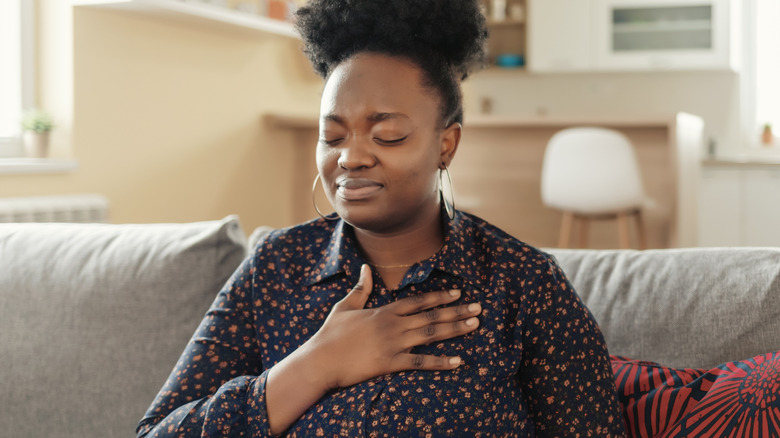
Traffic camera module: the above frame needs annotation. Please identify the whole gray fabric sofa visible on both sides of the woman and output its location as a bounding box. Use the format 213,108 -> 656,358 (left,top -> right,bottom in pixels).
0,217 -> 780,438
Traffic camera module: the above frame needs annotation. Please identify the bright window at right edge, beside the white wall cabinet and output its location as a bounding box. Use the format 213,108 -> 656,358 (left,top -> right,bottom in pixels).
742,0 -> 780,146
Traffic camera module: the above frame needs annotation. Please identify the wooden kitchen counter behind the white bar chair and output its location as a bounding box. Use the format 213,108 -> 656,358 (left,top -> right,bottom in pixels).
263,113 -> 703,248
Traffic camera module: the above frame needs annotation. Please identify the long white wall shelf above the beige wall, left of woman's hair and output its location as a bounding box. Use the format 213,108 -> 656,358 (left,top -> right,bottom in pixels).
72,0 -> 299,38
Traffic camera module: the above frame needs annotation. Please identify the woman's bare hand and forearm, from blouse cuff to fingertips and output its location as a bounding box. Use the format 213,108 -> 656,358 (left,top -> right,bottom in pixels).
266,265 -> 482,434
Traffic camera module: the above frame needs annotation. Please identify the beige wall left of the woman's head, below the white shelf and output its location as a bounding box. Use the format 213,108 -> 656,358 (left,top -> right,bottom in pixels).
0,0 -> 321,232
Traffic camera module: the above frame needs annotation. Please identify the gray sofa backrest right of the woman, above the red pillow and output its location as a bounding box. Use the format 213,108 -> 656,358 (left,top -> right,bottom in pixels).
546,248 -> 780,368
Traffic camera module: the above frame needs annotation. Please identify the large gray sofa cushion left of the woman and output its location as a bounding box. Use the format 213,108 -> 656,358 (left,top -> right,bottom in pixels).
0,217 -> 246,437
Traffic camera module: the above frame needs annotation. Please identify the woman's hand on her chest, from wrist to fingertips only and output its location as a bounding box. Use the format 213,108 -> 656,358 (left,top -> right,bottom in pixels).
307,265 -> 482,389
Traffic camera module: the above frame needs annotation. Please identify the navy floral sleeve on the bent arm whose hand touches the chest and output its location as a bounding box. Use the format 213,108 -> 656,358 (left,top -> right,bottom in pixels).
136,252 -> 272,438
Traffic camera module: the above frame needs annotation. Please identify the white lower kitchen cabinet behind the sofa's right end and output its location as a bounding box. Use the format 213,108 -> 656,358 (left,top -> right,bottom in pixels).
699,165 -> 780,246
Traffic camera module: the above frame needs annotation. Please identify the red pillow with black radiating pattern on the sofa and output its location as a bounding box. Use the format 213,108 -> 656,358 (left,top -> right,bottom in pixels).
611,352 -> 780,437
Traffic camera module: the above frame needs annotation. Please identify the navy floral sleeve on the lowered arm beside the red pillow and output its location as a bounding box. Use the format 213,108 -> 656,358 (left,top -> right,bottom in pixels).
517,257 -> 625,437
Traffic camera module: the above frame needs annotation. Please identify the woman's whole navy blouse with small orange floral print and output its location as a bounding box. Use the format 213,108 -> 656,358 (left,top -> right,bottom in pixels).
137,212 -> 624,437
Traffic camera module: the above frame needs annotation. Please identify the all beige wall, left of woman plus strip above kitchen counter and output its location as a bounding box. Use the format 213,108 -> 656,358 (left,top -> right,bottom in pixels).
0,0 -> 739,238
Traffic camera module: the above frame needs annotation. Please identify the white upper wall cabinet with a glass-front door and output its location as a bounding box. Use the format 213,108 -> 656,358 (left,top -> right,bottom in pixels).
528,0 -> 741,72
